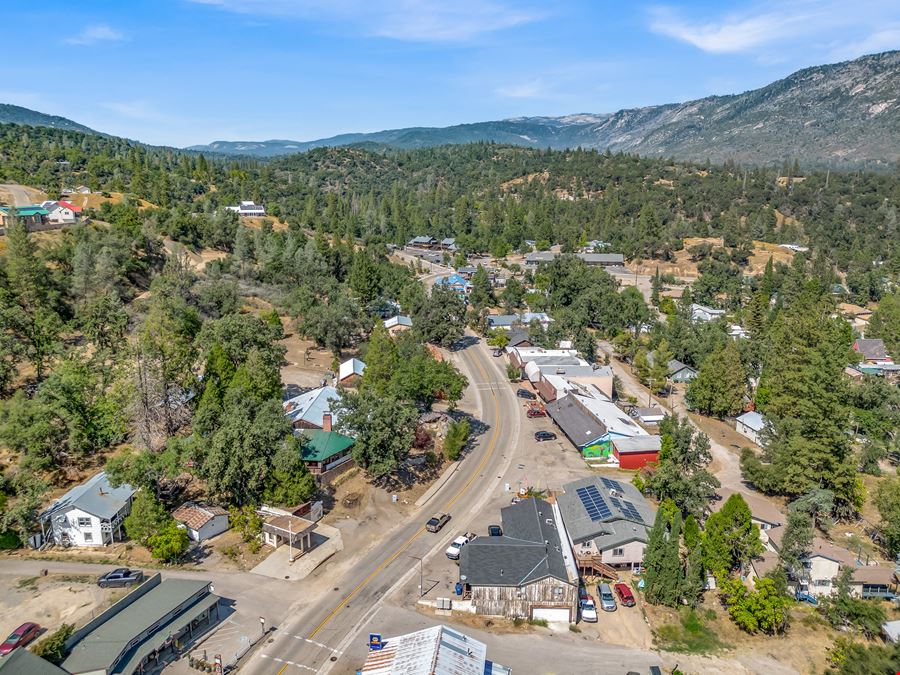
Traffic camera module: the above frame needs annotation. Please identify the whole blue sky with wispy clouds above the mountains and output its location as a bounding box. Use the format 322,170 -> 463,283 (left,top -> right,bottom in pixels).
0,0 -> 900,146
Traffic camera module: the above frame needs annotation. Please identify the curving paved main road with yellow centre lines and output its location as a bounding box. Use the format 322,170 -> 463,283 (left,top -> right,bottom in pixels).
242,340 -> 520,675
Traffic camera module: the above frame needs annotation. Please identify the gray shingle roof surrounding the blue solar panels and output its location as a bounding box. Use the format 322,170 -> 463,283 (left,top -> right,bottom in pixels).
556,476 -> 656,550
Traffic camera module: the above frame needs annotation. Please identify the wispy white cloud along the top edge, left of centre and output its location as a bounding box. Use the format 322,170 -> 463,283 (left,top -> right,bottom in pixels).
190,0 -> 542,42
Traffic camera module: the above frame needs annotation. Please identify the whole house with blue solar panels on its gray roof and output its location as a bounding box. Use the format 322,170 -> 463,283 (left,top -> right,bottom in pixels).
556,475 -> 656,573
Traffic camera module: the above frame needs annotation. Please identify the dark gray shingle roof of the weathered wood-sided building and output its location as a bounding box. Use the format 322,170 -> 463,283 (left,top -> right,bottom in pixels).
459,497 -> 571,586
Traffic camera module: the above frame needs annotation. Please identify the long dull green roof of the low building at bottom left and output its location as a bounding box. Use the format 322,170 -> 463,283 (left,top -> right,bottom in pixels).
62,579 -> 210,673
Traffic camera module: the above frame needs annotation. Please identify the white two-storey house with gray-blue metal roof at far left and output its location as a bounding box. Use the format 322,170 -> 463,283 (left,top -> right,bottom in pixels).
38,471 -> 136,546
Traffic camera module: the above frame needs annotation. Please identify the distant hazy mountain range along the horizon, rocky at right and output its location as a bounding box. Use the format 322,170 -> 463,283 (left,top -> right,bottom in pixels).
0,51 -> 900,167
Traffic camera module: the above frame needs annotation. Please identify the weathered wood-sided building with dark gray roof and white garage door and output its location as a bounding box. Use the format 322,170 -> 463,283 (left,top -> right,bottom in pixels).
459,497 -> 578,623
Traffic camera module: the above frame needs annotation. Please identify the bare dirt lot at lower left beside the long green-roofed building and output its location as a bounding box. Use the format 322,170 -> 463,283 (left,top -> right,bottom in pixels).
0,574 -> 127,636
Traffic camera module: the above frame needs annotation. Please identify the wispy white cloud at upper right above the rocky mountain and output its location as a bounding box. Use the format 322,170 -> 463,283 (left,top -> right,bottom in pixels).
650,0 -> 900,56
